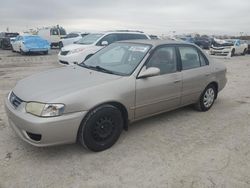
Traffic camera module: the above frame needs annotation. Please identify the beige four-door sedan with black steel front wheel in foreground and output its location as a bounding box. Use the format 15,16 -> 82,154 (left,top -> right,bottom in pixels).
5,40 -> 227,151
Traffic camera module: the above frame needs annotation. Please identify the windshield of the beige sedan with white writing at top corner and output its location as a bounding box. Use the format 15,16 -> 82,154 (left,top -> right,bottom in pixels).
79,43 -> 151,76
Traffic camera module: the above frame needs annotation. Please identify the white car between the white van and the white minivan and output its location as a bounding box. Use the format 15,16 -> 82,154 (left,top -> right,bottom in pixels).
59,32 -> 89,48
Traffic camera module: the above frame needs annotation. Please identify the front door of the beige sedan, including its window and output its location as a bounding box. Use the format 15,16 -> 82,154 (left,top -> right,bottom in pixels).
135,46 -> 182,119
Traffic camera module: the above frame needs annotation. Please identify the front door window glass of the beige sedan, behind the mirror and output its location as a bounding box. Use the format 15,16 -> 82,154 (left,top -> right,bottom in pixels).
146,46 -> 177,75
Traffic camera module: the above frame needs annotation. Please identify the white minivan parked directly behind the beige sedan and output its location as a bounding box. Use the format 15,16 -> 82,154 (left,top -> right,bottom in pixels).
58,30 -> 150,65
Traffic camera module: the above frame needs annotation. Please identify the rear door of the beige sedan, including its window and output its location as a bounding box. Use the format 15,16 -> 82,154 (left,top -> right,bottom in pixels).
178,45 -> 211,105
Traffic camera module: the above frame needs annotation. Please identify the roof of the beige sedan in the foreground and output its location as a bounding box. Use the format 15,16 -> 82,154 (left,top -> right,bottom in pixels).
118,39 -> 195,46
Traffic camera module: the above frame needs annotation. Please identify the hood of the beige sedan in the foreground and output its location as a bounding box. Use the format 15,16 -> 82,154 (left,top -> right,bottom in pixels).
13,65 -> 121,102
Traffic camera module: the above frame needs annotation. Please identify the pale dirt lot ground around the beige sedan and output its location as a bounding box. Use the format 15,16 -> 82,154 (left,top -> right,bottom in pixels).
0,50 -> 250,188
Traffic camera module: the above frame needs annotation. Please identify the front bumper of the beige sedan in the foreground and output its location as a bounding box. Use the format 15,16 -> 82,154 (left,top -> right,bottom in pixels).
5,98 -> 87,147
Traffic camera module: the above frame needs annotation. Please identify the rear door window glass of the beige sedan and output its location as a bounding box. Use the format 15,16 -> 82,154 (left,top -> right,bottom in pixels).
179,46 -> 200,70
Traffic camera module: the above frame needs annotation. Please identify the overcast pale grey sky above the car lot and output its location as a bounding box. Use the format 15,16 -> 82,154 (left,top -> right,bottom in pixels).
0,0 -> 250,35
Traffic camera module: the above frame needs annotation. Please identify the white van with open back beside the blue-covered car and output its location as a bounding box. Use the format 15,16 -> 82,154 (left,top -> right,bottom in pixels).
37,26 -> 66,47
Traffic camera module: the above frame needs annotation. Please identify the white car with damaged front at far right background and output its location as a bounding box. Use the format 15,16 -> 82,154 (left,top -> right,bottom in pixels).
210,39 -> 248,57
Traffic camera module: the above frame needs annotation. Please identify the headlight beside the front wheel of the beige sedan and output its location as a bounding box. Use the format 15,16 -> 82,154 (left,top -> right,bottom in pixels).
25,102 -> 64,117
